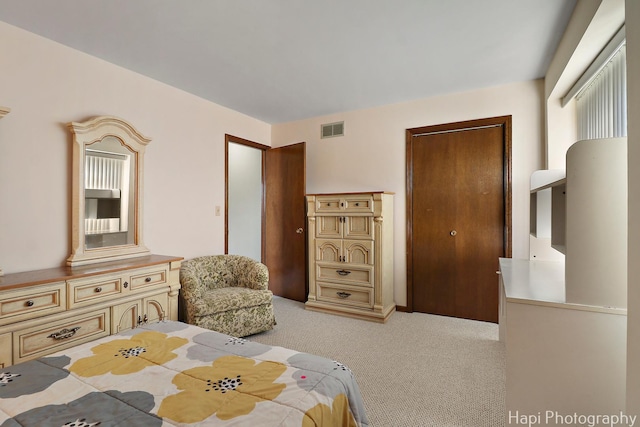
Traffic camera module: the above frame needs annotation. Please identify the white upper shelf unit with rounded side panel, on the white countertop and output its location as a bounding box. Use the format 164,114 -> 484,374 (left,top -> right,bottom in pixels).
530,138 -> 627,308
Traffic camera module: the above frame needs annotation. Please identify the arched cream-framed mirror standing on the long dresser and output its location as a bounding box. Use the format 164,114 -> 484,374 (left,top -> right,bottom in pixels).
67,116 -> 151,266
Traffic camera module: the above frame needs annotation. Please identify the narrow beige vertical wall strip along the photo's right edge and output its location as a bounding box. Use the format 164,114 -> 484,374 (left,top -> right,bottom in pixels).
626,0 -> 640,415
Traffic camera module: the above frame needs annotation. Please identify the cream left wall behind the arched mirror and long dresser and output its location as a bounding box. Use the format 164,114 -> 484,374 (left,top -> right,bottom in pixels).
0,22 -> 271,273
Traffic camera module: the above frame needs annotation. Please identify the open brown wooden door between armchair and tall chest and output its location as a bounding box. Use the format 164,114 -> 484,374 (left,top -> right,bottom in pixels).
265,142 -> 308,302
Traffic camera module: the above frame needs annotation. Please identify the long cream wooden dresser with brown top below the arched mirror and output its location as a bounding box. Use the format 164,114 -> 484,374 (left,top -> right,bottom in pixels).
0,255 -> 182,368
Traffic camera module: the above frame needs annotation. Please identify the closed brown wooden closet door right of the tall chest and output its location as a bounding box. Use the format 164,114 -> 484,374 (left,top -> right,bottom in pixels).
407,117 -> 511,322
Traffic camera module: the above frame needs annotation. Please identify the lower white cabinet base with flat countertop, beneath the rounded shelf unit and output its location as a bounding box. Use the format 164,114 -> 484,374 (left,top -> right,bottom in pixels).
499,258 -> 627,420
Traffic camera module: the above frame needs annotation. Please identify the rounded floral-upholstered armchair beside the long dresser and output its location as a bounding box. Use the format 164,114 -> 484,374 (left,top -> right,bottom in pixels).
180,255 -> 276,337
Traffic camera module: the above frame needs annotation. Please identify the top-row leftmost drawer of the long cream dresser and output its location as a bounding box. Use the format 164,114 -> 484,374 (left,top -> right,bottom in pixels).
0,282 -> 66,325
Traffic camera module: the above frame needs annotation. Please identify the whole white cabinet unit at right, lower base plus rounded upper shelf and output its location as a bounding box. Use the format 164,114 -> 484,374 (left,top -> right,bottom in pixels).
499,138 -> 627,425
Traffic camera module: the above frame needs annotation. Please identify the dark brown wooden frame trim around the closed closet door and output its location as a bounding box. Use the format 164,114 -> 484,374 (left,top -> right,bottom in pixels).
398,115 -> 512,312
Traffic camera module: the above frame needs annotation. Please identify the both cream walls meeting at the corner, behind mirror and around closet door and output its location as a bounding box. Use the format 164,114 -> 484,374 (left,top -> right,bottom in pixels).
0,23 -> 543,305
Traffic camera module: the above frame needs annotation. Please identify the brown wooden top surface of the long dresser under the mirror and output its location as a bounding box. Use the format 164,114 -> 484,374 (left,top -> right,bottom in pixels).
0,255 -> 184,291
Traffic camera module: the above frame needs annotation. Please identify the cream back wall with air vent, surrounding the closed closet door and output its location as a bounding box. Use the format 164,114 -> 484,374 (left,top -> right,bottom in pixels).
271,81 -> 543,306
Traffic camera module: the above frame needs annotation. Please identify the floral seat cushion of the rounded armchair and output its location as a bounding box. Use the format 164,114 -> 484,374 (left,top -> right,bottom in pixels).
197,288 -> 273,316
